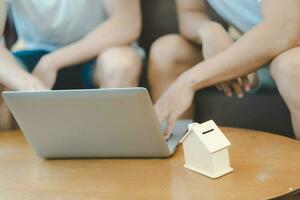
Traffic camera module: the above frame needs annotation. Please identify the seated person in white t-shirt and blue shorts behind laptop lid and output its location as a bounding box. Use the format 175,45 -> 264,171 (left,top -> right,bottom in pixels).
0,0 -> 142,130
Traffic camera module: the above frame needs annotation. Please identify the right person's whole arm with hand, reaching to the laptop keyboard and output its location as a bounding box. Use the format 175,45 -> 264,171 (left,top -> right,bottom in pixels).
155,0 -> 300,134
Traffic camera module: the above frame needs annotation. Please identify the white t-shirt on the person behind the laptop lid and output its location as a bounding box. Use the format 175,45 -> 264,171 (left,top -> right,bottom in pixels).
9,0 -> 107,50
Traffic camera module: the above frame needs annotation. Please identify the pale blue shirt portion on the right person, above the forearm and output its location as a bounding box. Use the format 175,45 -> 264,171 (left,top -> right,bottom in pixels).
207,0 -> 261,33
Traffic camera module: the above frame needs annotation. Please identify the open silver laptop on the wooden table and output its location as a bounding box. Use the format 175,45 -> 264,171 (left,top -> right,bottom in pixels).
3,88 -> 190,158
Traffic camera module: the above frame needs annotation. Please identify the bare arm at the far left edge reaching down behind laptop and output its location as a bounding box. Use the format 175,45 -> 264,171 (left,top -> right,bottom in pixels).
0,0 -> 46,90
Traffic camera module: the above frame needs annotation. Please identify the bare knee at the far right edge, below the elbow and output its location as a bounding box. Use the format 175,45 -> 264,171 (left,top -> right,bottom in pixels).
270,53 -> 300,86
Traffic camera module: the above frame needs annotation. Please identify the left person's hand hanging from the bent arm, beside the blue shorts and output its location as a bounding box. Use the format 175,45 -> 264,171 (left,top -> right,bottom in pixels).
32,55 -> 58,89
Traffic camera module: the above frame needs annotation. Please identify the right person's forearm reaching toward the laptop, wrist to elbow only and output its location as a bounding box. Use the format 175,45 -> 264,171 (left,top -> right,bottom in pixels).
184,23 -> 299,90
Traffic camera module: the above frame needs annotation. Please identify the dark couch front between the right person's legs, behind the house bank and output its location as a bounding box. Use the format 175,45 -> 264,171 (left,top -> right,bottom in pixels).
194,87 -> 294,138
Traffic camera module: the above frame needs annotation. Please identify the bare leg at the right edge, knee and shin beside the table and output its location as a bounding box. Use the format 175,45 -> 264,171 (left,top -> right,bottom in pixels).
271,47 -> 300,140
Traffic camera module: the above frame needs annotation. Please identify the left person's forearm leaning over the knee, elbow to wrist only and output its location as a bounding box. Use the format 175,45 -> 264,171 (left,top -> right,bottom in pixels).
44,17 -> 140,69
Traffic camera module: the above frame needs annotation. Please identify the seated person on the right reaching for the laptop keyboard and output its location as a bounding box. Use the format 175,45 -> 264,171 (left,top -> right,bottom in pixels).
149,0 -> 300,139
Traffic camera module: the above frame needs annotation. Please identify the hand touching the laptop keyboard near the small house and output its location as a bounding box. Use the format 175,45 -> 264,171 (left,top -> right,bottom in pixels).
154,74 -> 195,139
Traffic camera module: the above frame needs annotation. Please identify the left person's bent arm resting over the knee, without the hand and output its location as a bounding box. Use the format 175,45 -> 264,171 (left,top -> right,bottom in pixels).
42,0 -> 141,69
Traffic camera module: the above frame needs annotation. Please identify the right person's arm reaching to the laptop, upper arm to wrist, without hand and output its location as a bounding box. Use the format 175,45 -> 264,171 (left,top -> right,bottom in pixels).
183,0 -> 300,90
